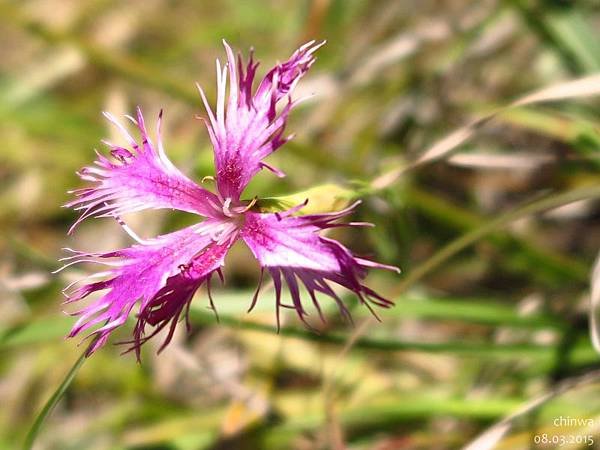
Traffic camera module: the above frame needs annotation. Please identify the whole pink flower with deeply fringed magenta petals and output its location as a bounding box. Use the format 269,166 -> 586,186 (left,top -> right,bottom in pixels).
63,42 -> 397,359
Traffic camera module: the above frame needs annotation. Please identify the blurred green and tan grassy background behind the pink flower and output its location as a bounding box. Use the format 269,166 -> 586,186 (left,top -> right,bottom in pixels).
0,0 -> 600,450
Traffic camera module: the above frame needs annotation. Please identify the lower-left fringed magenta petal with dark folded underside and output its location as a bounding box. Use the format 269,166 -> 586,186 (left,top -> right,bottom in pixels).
65,219 -> 237,354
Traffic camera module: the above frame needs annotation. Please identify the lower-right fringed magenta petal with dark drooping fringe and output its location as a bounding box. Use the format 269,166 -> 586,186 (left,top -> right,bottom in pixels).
241,207 -> 398,325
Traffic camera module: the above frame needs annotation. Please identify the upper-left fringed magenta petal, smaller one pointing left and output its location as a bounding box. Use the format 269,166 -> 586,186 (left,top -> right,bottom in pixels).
65,108 -> 220,231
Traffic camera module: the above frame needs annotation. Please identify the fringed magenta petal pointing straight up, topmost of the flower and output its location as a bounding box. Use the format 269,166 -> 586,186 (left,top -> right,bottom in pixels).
200,41 -> 323,201
